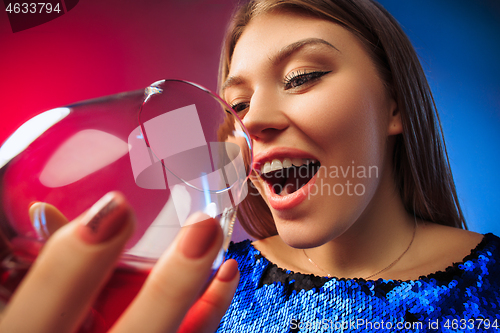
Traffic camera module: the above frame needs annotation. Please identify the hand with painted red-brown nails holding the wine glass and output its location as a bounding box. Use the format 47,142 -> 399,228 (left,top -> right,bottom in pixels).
0,193 -> 239,333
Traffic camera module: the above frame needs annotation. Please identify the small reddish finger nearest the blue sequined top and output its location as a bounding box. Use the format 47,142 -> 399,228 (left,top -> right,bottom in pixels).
178,259 -> 240,333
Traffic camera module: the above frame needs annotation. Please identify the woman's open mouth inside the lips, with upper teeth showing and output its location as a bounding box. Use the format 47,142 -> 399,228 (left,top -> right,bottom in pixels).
261,158 -> 321,196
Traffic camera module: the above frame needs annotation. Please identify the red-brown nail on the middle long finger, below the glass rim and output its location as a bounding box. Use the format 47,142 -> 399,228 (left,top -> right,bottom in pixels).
179,214 -> 220,259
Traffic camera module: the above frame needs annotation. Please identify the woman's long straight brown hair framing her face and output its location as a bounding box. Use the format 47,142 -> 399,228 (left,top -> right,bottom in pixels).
219,0 -> 467,238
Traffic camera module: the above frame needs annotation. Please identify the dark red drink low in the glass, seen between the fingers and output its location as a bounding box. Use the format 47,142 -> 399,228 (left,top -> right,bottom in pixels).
0,254 -> 149,333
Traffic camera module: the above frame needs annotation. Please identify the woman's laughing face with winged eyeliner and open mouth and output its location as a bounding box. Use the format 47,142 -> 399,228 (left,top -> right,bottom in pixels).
223,12 -> 400,247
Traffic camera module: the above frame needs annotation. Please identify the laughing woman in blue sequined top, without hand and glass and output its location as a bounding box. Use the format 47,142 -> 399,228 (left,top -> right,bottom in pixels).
219,0 -> 500,332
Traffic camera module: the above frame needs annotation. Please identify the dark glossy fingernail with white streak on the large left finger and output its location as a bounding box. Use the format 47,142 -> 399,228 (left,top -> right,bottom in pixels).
79,193 -> 129,244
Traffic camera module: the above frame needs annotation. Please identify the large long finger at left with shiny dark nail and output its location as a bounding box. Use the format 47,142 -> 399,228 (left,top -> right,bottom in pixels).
0,193 -> 134,333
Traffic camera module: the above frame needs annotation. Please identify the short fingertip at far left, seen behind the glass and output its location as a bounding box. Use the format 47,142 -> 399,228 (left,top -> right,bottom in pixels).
29,202 -> 68,240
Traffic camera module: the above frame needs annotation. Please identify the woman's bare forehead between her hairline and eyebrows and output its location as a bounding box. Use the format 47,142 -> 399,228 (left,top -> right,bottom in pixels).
230,12 -> 364,74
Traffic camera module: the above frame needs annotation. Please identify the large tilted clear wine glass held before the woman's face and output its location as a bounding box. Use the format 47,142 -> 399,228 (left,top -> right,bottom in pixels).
0,79 -> 252,332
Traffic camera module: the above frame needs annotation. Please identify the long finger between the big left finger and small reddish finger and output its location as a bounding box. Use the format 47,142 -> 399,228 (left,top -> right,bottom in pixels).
112,213 -> 226,333
